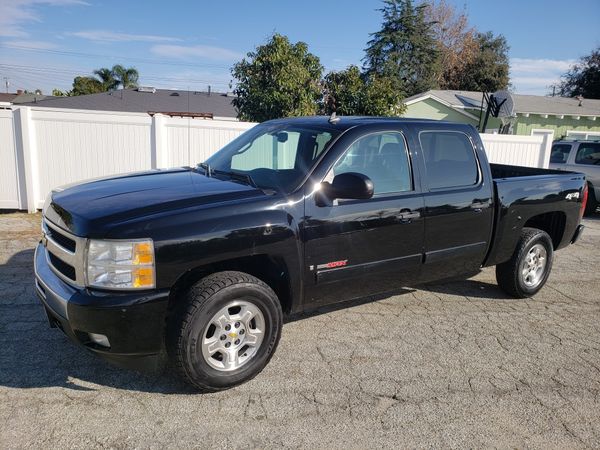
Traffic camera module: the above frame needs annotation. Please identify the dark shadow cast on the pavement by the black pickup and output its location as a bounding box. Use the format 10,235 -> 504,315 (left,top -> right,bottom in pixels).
0,249 -> 508,394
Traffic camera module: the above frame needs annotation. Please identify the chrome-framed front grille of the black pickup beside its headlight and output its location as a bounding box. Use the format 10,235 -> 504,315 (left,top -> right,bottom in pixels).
42,217 -> 86,286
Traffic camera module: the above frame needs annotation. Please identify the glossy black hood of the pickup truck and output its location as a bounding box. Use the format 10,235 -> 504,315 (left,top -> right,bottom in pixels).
44,168 -> 265,237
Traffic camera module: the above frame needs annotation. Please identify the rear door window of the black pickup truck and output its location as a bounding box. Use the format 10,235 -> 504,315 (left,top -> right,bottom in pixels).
419,131 -> 479,189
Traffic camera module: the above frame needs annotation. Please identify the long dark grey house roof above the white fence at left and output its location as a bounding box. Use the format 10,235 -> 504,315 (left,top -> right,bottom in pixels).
25,87 -> 237,120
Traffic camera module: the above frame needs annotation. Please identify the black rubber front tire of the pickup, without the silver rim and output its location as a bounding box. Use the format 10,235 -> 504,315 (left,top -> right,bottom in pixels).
167,271 -> 283,392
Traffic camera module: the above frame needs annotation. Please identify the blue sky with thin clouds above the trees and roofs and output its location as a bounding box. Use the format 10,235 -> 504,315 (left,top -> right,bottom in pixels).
0,0 -> 600,95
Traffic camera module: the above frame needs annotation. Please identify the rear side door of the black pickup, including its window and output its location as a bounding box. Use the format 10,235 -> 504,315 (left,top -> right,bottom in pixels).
418,128 -> 494,281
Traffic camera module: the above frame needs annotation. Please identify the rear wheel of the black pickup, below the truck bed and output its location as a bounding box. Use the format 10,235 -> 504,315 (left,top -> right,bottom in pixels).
496,228 -> 554,298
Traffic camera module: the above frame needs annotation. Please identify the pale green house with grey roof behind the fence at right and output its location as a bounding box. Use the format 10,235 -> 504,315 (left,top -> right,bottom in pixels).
404,90 -> 600,139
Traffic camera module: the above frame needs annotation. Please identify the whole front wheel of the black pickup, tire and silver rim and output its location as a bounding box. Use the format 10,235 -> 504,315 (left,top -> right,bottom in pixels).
167,271 -> 283,392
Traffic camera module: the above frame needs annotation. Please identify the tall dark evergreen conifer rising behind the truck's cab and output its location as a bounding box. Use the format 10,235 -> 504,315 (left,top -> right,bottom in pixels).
363,0 -> 440,95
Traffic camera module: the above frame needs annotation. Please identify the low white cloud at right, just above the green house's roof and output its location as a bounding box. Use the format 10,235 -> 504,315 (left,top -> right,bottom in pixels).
510,58 -> 575,95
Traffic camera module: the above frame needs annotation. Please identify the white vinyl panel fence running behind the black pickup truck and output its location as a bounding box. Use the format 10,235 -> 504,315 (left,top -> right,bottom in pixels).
0,107 -> 552,212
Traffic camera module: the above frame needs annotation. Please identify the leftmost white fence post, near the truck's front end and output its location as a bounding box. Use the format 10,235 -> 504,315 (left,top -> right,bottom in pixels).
13,106 -> 39,213
